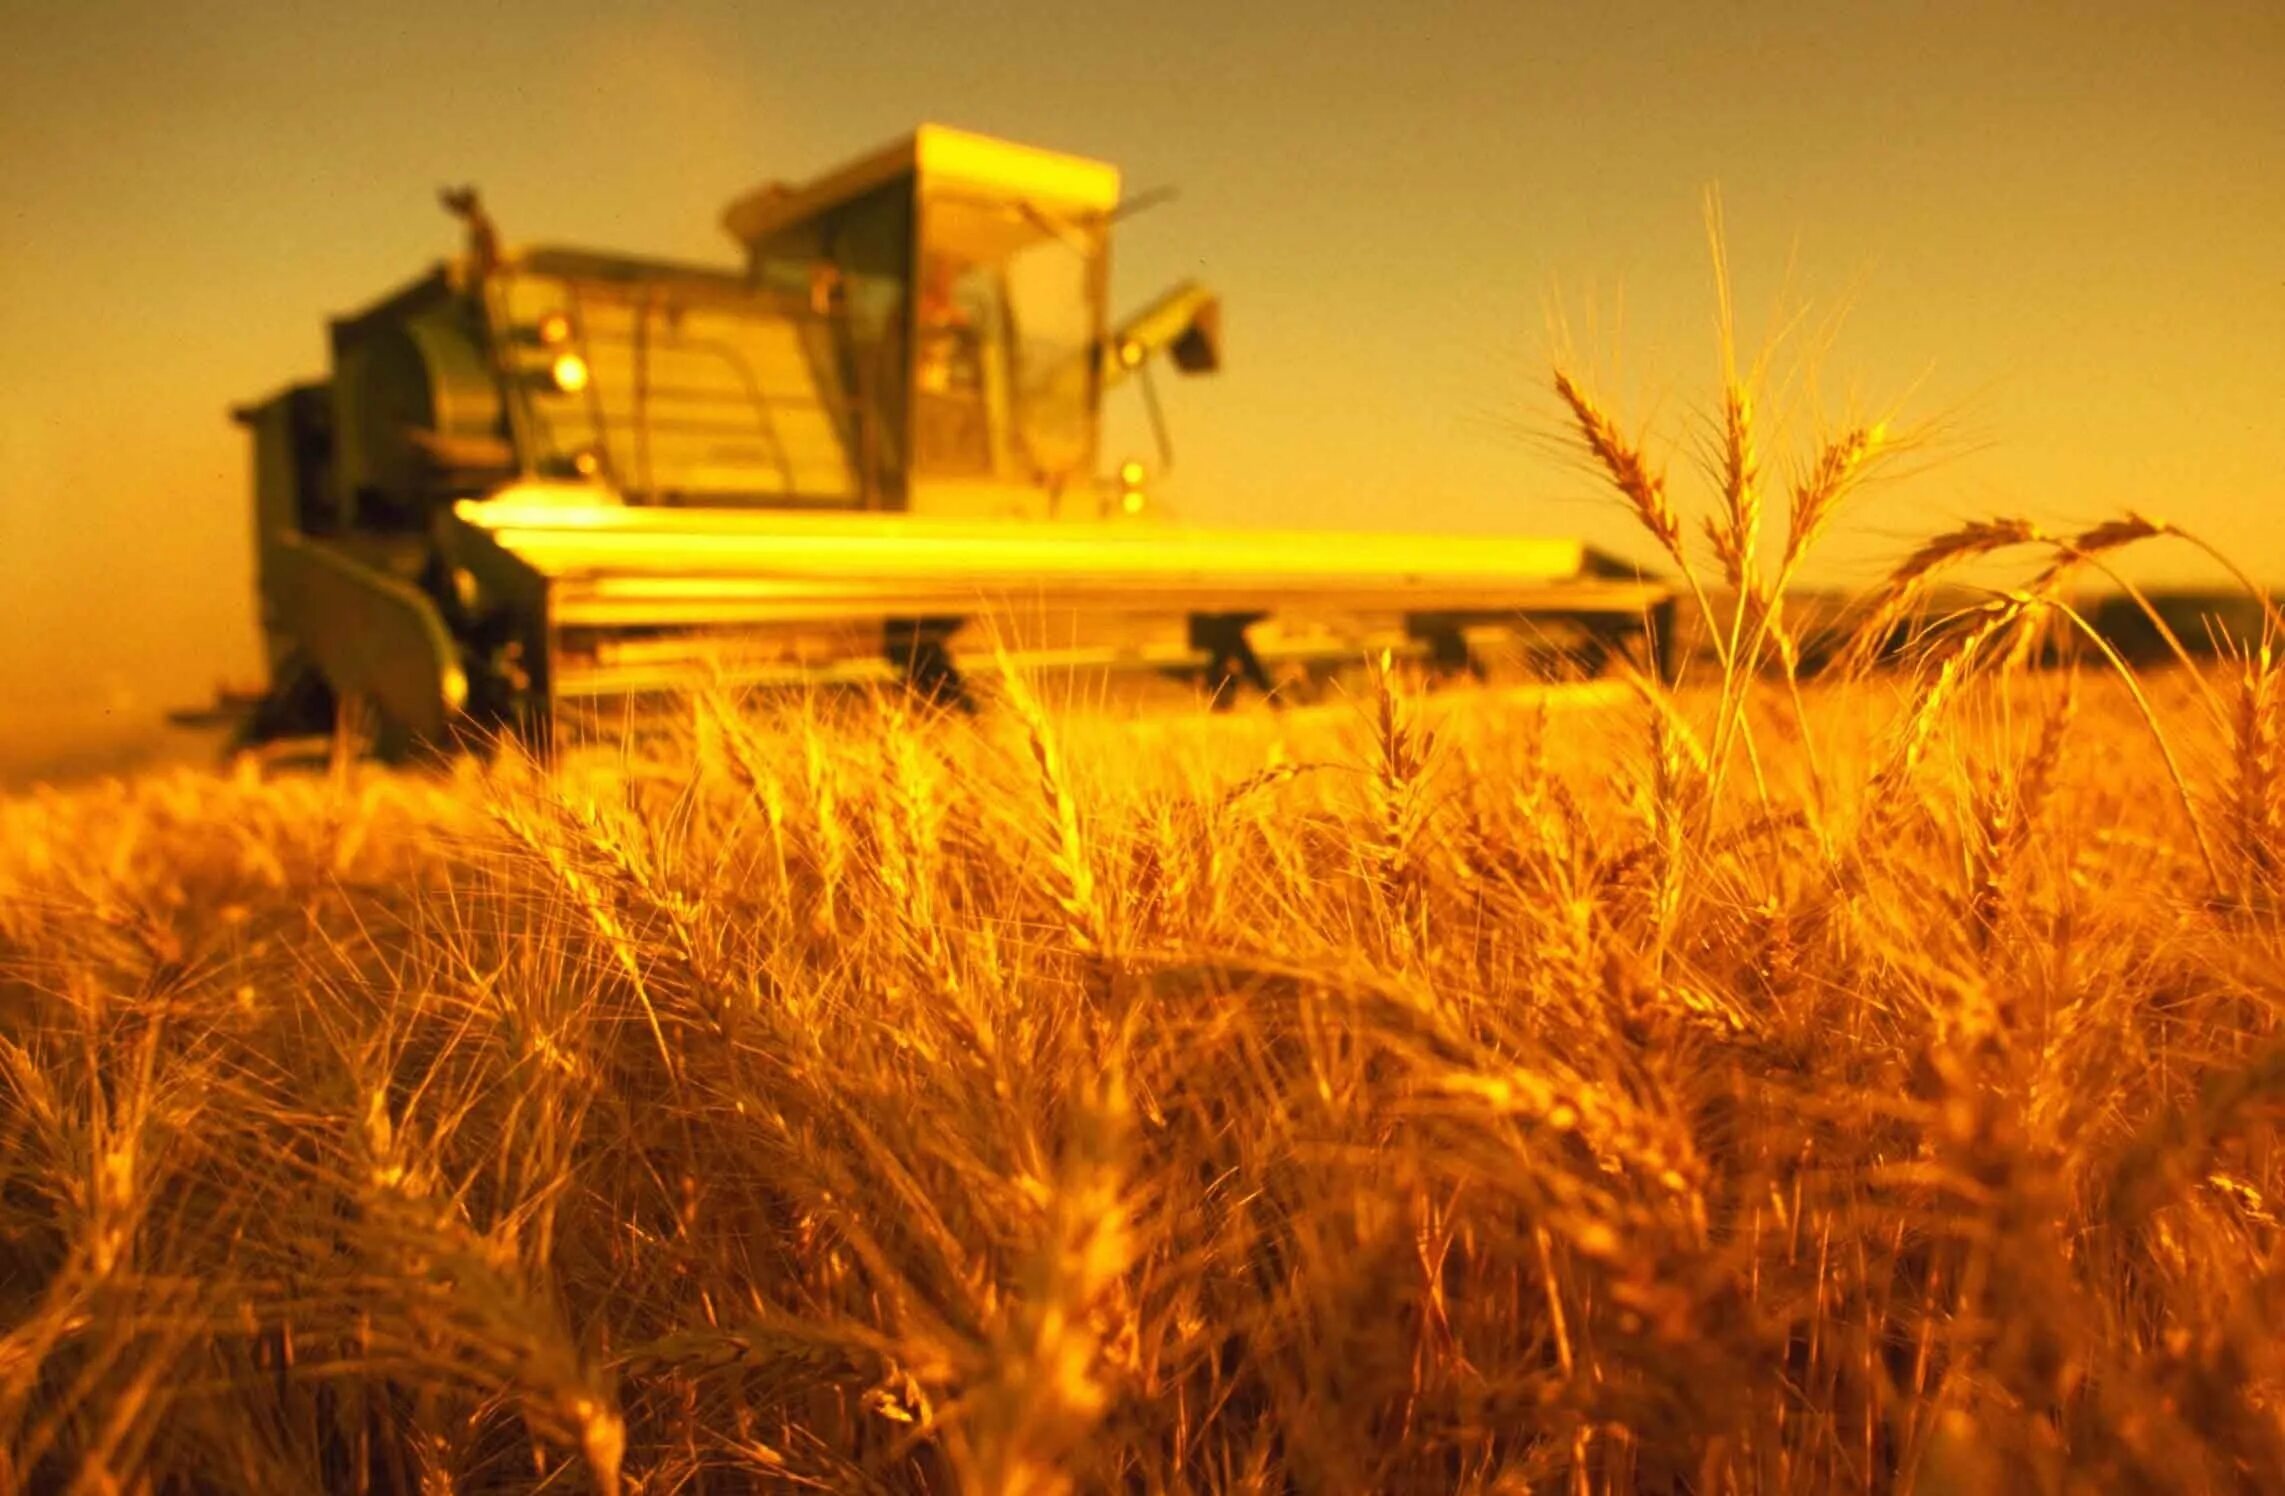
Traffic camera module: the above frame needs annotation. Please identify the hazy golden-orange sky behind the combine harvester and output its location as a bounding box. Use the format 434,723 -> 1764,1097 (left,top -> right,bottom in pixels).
0,0 -> 2285,756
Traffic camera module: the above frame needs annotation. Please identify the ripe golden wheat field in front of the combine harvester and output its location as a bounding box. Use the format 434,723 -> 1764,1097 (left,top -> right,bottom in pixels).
0,356 -> 2285,1496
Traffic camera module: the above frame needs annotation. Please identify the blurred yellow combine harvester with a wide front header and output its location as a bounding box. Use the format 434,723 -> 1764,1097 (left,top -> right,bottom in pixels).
222,126 -> 1673,751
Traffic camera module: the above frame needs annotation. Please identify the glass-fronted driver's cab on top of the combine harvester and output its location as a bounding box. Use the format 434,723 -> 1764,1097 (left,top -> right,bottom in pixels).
722,126 -> 1218,521
